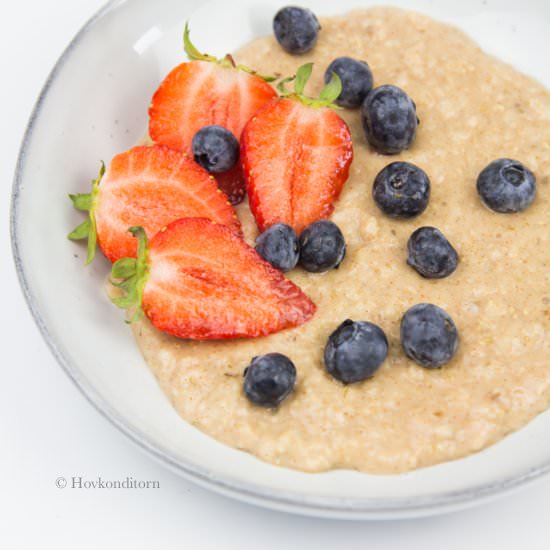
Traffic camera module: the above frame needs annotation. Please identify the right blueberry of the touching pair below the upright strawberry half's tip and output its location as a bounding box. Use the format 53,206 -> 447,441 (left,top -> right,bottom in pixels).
300,220 -> 346,273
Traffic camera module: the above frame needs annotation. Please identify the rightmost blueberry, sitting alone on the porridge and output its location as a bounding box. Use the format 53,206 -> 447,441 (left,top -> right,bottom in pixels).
477,159 -> 537,214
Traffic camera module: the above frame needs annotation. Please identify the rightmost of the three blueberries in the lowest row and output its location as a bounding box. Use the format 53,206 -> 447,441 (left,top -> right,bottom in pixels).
401,304 -> 458,369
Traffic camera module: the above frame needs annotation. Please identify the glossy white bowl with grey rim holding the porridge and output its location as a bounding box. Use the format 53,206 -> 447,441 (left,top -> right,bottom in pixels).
12,0 -> 550,518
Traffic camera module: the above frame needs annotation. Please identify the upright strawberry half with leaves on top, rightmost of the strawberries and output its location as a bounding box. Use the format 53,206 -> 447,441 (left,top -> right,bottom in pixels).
241,63 -> 353,234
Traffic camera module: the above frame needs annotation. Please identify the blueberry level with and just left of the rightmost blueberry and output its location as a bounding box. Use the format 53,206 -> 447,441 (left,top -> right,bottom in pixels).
372,162 -> 430,218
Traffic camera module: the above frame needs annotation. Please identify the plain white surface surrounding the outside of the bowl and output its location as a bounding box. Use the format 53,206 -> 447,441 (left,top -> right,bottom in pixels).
0,0 -> 550,550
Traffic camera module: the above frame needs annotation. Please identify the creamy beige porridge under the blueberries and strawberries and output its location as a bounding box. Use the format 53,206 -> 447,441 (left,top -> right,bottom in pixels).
130,8 -> 550,473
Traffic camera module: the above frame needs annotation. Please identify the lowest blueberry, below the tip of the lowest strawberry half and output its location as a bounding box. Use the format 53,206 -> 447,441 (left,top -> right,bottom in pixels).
244,353 -> 296,407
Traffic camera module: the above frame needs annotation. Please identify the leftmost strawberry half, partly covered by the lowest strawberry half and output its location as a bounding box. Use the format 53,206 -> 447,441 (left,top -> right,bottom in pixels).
69,145 -> 241,263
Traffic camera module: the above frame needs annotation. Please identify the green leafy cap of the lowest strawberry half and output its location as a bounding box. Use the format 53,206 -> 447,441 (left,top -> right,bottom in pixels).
111,227 -> 149,323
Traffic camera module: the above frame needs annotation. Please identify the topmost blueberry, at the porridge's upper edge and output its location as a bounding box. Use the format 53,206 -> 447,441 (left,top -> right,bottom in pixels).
273,6 -> 321,54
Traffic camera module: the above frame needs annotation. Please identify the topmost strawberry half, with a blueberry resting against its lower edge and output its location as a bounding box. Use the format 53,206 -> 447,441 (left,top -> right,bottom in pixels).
149,24 -> 277,204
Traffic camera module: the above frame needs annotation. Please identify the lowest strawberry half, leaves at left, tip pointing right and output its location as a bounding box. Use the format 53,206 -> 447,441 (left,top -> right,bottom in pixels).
112,218 -> 315,340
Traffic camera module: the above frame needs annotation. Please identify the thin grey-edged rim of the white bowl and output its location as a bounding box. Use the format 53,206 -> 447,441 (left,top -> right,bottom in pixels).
10,0 -> 550,519
